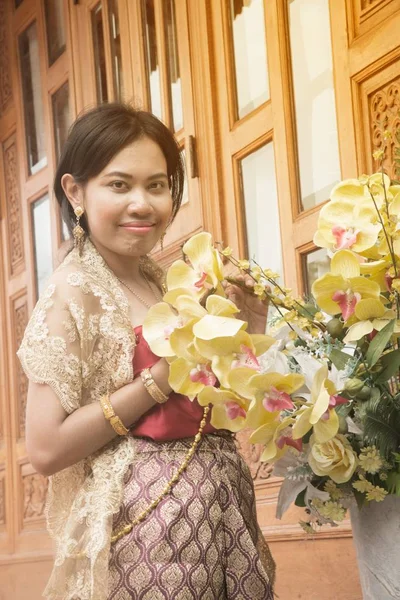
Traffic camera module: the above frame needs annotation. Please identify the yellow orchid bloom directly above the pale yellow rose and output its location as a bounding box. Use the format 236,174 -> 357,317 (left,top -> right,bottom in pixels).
293,365 -> 348,443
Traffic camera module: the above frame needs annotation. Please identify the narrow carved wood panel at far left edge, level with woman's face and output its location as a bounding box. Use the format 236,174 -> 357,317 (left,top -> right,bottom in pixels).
3,134 -> 24,275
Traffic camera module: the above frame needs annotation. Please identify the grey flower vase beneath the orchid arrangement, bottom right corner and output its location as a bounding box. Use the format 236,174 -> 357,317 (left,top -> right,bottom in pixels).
350,495 -> 400,600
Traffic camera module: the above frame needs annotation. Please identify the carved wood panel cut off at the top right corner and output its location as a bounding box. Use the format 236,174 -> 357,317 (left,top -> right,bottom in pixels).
347,0 -> 400,38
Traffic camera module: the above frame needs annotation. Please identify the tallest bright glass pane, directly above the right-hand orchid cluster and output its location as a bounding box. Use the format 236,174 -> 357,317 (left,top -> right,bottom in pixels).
288,0 -> 341,210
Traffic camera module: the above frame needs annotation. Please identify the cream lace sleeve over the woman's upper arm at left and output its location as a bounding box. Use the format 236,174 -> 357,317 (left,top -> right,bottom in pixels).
17,282 -> 84,414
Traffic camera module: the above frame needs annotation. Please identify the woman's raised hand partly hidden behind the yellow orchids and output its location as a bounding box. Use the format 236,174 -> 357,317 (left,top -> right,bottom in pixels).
224,274 -> 269,333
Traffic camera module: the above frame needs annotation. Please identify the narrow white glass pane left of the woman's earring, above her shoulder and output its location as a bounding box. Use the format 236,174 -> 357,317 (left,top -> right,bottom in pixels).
32,194 -> 53,295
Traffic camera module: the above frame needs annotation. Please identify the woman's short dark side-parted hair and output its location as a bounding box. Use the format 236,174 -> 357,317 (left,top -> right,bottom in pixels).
54,102 -> 184,234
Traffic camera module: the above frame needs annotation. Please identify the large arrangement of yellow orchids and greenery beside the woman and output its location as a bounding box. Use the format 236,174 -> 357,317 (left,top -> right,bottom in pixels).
143,153 -> 400,532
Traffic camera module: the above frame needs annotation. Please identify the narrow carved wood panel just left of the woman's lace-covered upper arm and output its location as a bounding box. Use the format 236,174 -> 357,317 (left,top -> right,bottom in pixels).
12,295 -> 29,437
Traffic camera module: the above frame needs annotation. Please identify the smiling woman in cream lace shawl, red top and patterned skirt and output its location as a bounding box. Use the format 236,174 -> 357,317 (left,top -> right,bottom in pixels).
18,104 -> 273,600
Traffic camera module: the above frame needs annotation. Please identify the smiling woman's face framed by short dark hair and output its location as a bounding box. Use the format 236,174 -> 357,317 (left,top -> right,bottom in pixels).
83,137 -> 172,256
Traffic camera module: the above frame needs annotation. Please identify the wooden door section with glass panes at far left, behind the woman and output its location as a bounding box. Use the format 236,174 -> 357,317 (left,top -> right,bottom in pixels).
0,0 -> 74,600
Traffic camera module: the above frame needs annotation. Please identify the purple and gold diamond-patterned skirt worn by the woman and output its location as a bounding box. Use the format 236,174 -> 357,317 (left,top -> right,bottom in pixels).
108,434 -> 275,600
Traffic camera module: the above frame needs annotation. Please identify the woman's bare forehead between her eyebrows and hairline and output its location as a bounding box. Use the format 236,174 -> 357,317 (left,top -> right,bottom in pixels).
99,137 -> 167,177
